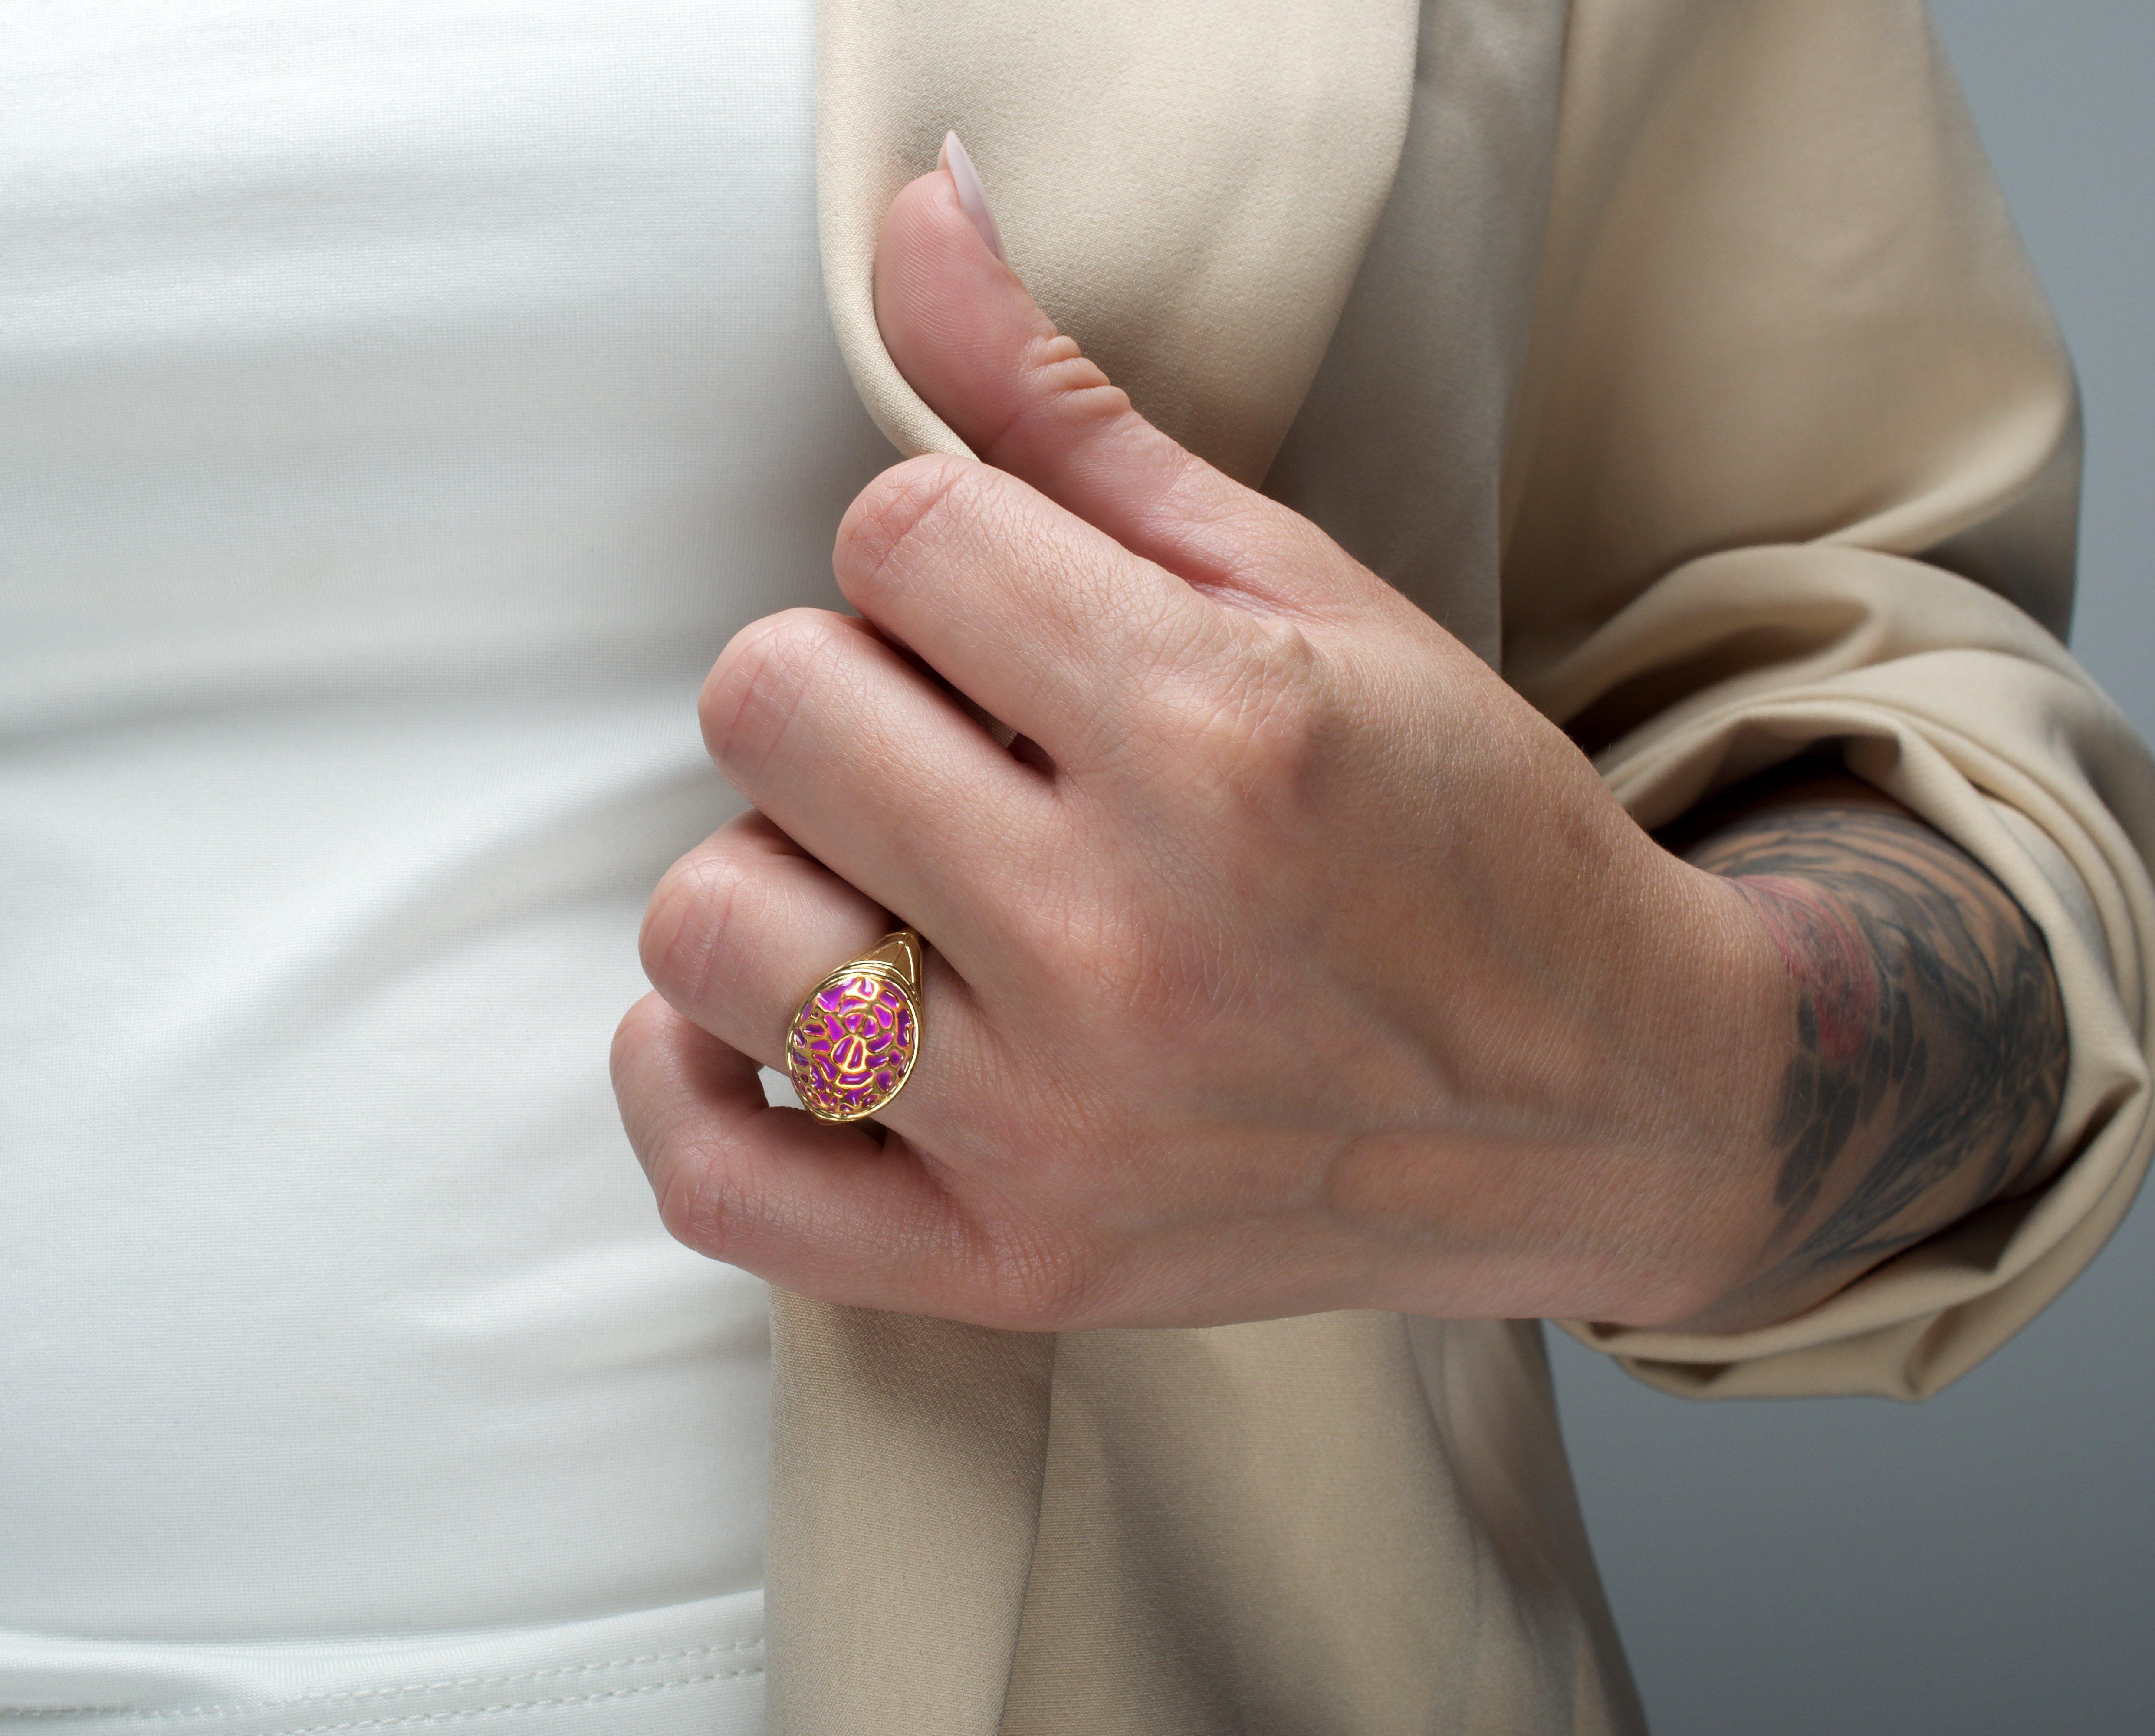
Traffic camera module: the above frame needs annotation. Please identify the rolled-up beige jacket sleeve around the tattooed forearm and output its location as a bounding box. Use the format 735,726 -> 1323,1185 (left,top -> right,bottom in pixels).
1504,0 -> 2155,1397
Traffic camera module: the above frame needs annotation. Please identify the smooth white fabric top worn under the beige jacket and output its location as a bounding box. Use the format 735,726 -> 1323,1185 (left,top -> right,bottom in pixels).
0,0 -> 890,1736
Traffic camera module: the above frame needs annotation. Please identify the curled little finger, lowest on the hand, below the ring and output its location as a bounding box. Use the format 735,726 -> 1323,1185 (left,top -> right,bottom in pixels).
614,994 -> 979,1307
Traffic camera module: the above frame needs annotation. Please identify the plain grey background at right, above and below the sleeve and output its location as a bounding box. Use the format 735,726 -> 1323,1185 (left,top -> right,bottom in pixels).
1552,0 -> 2155,1736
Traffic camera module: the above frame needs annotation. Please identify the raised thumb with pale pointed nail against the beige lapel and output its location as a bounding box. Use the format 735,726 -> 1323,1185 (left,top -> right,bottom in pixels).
875,134 -> 1310,593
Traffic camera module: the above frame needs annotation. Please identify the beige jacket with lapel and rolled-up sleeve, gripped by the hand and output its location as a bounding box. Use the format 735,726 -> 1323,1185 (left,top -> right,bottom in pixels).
769,0 -> 2155,1736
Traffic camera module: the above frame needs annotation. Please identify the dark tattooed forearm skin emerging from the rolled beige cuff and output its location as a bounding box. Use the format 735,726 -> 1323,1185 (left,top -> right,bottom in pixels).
1685,779 -> 2066,1289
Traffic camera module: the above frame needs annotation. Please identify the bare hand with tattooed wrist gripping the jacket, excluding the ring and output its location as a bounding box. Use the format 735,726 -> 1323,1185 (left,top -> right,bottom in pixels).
614,173 -> 2064,1328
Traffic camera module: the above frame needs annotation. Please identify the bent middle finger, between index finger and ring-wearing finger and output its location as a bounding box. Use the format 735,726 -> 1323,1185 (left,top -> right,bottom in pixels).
700,608 -> 1060,962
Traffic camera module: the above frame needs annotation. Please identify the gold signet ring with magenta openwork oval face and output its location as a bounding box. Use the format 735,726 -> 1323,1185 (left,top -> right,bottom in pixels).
787,927 -> 924,1121
